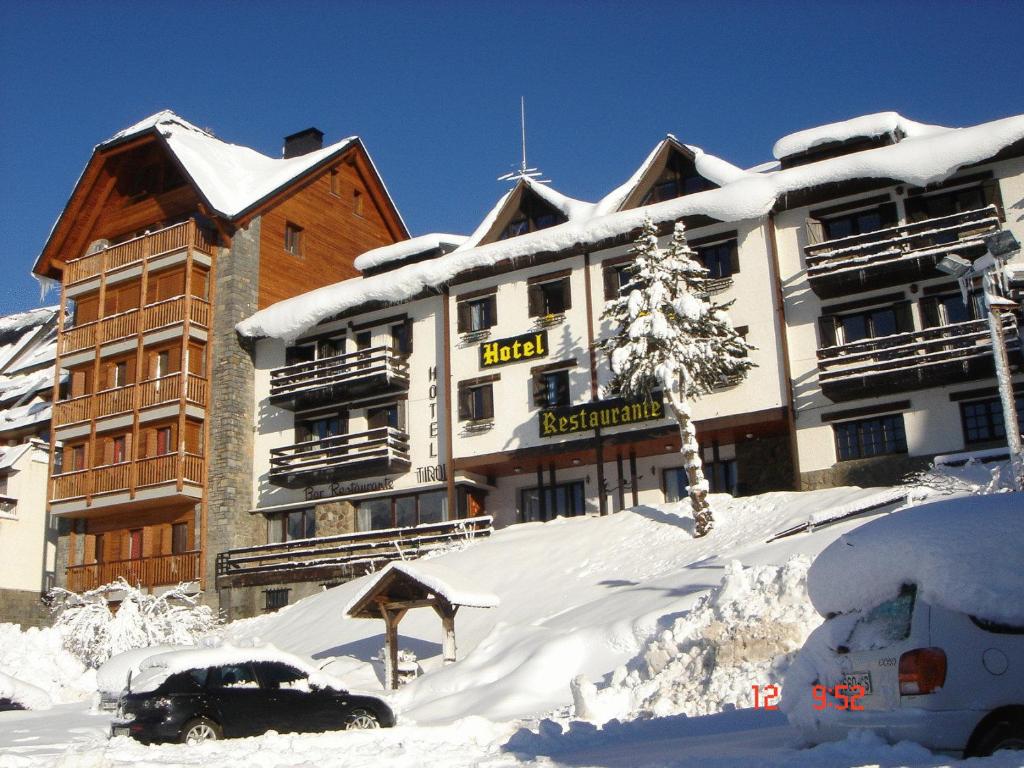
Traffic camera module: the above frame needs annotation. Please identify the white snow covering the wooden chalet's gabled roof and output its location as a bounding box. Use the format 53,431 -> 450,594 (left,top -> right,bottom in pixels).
96,110 -> 358,218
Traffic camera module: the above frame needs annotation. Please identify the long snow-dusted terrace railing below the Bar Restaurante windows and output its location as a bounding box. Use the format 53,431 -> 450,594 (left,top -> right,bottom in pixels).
217,515 -> 494,584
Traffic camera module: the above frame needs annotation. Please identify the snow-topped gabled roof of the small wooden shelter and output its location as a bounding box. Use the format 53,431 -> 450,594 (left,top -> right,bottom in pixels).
345,560 -> 499,618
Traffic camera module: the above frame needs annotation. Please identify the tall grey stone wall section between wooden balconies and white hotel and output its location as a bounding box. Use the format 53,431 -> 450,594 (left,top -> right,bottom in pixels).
205,218 -> 264,618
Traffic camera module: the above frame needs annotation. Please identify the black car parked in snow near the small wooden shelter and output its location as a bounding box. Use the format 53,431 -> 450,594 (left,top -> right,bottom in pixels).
111,662 -> 395,743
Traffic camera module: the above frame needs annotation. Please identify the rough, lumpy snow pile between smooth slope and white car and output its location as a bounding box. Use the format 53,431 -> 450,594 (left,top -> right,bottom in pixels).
572,557 -> 821,723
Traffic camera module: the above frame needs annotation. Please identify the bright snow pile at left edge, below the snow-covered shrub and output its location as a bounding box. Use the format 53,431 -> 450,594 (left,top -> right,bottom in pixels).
0,624 -> 95,709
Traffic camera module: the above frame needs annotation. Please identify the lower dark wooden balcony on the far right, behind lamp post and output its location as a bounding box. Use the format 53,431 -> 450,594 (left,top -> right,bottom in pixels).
818,314 -> 1021,402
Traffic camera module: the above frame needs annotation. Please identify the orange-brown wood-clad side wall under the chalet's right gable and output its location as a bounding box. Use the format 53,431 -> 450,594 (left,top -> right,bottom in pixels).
259,160 -> 395,309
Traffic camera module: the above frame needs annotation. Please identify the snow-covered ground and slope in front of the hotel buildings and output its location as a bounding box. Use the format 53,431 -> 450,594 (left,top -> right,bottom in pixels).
0,479 -> 1022,768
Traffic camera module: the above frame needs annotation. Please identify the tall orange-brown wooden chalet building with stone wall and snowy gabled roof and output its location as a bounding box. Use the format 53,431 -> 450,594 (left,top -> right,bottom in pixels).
33,112 -> 408,590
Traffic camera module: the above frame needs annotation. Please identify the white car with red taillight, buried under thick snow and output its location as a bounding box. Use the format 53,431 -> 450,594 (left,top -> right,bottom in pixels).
781,493 -> 1024,757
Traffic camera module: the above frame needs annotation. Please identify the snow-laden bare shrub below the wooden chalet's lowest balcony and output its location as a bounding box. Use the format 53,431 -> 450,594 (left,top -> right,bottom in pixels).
50,579 -> 217,668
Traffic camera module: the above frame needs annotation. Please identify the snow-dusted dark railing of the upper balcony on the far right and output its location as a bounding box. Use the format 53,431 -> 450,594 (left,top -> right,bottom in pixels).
804,205 -> 999,288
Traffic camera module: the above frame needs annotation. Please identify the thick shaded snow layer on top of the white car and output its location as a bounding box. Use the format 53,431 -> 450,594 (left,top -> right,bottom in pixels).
808,493 -> 1024,625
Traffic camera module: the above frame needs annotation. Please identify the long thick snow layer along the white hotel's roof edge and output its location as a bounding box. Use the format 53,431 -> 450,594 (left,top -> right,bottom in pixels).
236,115 -> 1024,340
